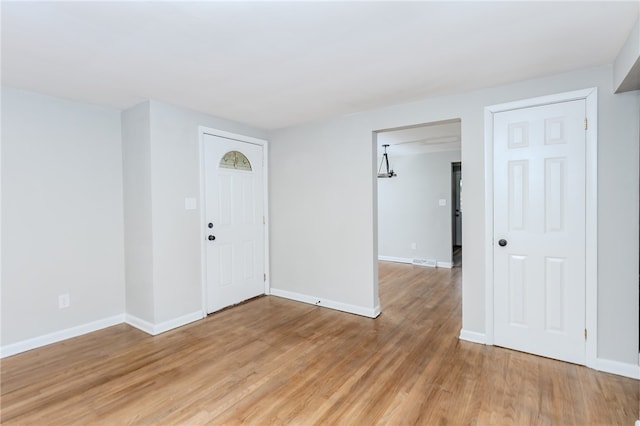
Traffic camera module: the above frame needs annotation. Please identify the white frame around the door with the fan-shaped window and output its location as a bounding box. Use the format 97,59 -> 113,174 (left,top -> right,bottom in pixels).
198,126 -> 271,318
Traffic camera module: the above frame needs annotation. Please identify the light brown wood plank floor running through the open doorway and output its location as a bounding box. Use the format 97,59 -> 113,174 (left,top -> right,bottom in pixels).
0,263 -> 640,426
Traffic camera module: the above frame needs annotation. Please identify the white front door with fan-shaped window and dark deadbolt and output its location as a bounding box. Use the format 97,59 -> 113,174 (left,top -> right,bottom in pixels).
202,134 -> 265,313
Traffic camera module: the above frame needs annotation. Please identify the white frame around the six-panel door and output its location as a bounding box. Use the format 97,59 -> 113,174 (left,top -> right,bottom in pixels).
484,87 -> 598,368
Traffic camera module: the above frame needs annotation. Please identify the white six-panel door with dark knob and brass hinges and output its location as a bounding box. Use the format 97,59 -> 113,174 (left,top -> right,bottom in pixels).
493,99 -> 586,364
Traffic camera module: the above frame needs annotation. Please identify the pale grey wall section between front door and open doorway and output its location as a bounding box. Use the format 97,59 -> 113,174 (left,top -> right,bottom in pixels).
269,117 -> 380,311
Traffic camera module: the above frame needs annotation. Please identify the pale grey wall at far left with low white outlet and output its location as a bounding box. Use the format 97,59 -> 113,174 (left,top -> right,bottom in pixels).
1,88 -> 125,346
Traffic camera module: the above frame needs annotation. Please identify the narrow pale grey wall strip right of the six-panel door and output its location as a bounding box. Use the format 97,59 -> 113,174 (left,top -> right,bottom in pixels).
598,84 -> 640,365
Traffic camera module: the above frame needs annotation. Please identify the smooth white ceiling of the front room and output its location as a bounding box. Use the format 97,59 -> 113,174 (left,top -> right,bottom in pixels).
1,1 -> 639,129
